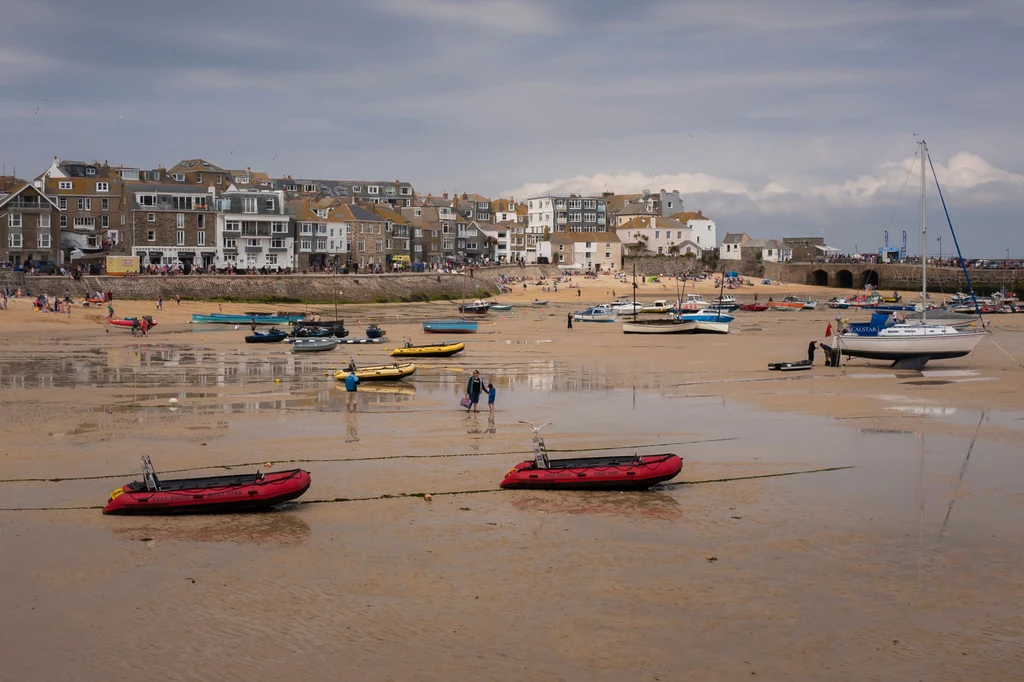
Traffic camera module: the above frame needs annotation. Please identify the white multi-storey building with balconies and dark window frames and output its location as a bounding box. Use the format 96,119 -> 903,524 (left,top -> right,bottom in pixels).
215,188 -> 296,270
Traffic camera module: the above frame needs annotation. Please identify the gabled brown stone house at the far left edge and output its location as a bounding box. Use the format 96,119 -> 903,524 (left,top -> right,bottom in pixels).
0,175 -> 61,266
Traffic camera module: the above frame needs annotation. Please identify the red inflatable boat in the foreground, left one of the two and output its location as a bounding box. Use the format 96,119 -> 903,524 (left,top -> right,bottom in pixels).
103,455 -> 310,514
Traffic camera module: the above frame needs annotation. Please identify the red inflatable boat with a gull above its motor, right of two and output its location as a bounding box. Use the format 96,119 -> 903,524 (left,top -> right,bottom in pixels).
501,425 -> 683,491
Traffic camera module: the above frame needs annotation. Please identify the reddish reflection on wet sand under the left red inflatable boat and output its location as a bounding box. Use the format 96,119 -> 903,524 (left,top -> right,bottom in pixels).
112,505 -> 310,545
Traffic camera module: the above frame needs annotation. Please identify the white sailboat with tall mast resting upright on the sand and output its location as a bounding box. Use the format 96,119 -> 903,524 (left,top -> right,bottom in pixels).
835,140 -> 987,369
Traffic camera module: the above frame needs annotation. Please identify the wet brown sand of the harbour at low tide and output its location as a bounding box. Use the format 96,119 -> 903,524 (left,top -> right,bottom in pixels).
0,280 -> 1024,680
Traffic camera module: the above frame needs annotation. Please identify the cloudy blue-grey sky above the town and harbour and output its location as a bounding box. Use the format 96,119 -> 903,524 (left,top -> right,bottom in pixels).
6,0 -> 1024,258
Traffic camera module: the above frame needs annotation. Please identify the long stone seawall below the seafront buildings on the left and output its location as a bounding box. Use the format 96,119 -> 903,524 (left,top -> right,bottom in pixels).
0,265 -> 558,303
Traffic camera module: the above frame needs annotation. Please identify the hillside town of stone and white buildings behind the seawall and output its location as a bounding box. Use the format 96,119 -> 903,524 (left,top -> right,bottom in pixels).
0,158 -> 737,273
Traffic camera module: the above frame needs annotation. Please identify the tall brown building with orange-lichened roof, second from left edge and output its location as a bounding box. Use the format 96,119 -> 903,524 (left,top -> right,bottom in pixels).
38,157 -> 124,260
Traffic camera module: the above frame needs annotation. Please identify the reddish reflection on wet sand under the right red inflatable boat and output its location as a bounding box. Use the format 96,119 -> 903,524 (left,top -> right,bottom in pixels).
510,491 -> 683,520
